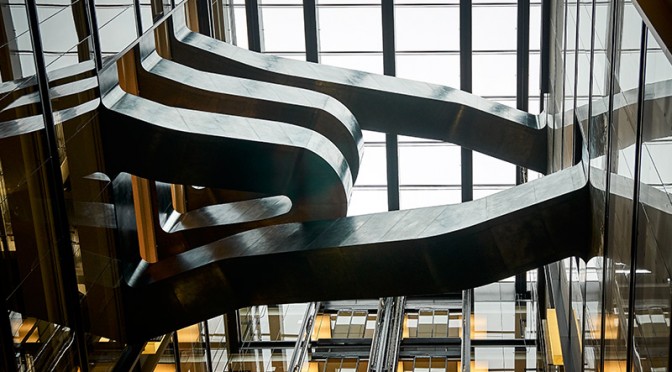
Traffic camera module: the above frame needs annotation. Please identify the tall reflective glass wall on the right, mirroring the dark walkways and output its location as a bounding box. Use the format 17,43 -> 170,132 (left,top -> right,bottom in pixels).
548,0 -> 672,371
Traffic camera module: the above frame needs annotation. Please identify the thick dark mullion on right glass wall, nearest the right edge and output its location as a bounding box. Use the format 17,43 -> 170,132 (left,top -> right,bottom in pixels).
625,22 -> 652,371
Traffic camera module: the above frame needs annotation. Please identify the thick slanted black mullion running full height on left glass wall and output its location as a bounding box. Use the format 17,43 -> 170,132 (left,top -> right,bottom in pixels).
26,1 -> 88,372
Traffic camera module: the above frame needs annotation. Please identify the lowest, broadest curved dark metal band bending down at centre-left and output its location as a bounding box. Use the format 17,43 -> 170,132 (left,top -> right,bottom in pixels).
101,82 -> 352,221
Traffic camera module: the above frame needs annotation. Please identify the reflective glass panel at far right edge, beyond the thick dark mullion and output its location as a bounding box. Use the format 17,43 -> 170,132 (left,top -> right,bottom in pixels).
634,28 -> 672,371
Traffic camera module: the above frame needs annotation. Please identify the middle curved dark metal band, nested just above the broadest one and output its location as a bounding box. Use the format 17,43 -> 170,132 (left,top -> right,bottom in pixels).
138,41 -> 364,180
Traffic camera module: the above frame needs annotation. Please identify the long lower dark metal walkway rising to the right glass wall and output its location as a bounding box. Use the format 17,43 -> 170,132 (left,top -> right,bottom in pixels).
126,166 -> 591,340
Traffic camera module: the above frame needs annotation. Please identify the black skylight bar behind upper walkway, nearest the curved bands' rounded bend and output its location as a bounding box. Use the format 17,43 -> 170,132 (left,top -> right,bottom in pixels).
381,0 -> 399,211
